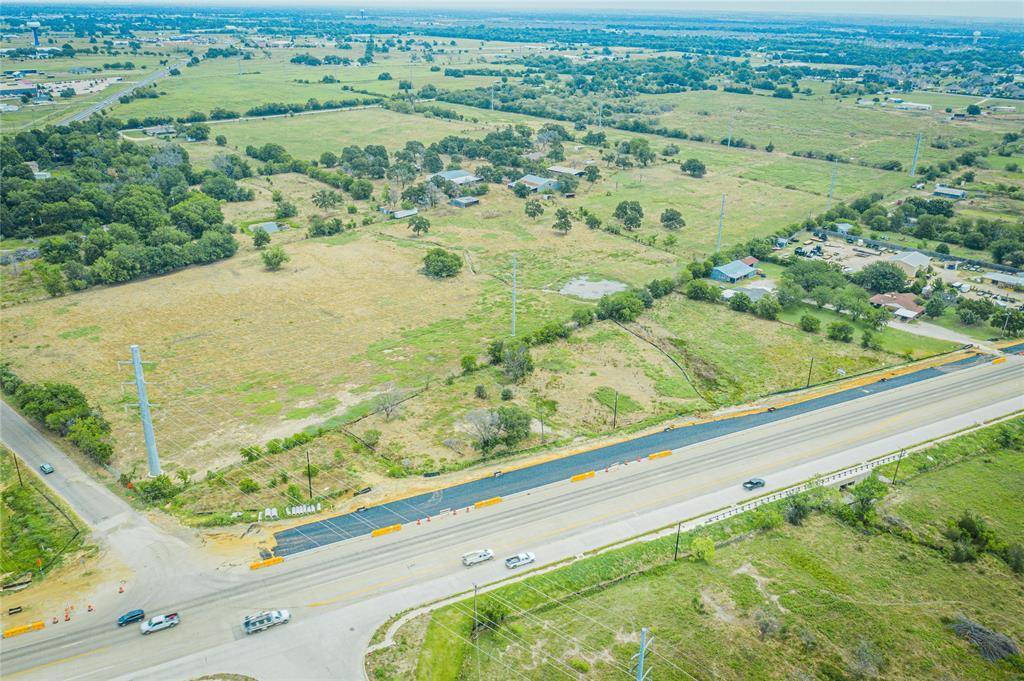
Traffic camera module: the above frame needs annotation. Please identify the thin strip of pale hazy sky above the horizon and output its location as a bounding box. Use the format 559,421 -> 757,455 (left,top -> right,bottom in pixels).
7,0 -> 1024,19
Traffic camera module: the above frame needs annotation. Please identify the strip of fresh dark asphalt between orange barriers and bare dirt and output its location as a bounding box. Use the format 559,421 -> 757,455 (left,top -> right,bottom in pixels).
273,346 -> 983,556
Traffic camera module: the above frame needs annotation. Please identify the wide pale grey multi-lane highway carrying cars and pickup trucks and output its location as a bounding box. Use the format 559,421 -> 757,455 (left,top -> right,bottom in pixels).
0,356 -> 1024,681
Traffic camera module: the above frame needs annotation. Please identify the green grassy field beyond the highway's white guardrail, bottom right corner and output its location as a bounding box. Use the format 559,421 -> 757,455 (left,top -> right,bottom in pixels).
369,420 -> 1024,681
